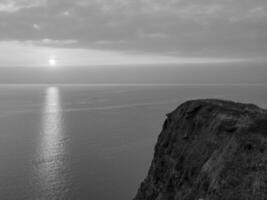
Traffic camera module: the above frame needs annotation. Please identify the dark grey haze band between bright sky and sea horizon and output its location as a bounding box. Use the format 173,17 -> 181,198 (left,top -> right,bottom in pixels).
0,62 -> 267,84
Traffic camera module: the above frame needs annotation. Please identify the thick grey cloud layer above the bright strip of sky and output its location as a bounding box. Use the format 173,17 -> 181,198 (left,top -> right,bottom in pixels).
0,0 -> 267,57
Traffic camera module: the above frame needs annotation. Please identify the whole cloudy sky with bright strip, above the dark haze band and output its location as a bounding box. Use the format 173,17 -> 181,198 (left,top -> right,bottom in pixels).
0,0 -> 267,66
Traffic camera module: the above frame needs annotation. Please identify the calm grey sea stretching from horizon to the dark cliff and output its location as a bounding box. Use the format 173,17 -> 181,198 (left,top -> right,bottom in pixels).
0,85 -> 267,200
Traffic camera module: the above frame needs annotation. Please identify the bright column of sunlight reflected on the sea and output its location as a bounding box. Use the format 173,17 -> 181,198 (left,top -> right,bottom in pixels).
37,87 -> 68,200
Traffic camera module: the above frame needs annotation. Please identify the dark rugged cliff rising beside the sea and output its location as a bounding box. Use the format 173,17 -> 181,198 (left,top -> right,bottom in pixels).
134,99 -> 267,200
